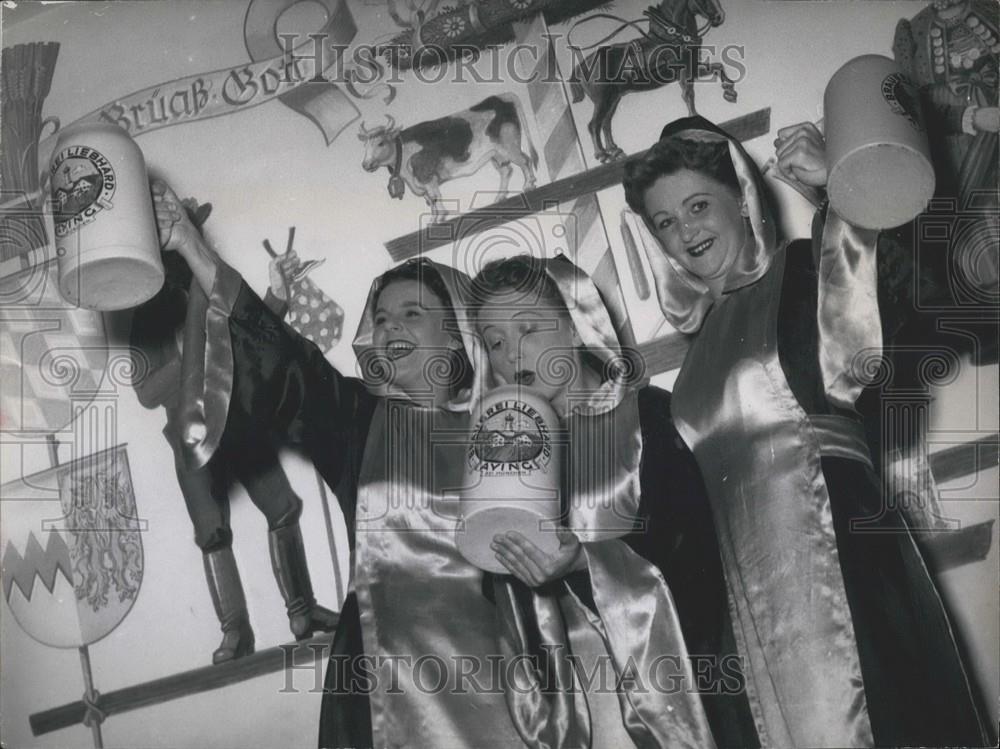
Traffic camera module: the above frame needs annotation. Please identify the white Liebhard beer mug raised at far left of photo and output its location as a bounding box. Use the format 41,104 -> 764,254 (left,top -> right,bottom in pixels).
49,124 -> 163,311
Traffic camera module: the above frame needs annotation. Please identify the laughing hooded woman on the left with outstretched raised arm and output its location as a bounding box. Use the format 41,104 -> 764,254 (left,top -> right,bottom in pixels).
154,186 -> 556,749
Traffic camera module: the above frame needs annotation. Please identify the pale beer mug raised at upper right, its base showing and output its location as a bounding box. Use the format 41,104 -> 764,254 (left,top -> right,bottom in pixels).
823,55 -> 935,229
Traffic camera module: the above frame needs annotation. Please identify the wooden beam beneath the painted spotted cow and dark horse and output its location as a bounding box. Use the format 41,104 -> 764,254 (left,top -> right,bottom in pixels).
385,107 -> 771,262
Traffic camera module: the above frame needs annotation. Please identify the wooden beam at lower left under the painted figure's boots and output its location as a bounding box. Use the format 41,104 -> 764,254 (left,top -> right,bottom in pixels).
28,633 -> 333,736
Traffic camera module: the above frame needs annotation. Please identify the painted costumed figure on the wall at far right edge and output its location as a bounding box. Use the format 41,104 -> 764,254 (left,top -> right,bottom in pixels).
892,0 -> 1000,364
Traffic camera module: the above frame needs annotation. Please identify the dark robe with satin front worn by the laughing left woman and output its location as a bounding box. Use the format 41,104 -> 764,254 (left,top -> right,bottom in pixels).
220,272 -> 522,749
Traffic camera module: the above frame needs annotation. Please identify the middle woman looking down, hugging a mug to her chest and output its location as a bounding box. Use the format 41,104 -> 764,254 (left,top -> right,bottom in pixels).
471,255 -> 756,746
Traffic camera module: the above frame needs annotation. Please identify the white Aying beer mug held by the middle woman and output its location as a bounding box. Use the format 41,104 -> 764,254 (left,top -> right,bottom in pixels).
456,385 -> 561,573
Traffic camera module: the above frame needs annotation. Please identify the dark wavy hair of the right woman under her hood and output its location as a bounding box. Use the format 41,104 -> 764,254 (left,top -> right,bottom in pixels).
622,136 -> 742,221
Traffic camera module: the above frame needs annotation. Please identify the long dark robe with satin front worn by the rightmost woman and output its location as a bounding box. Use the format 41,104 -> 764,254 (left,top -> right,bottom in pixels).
674,241 -> 986,747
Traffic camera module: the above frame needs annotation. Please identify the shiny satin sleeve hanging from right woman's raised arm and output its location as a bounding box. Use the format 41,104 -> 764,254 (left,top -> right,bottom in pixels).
816,209 -> 882,409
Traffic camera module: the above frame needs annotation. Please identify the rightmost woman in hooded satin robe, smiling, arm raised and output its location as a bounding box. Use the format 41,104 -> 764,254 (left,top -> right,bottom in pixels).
624,118 -> 988,747
